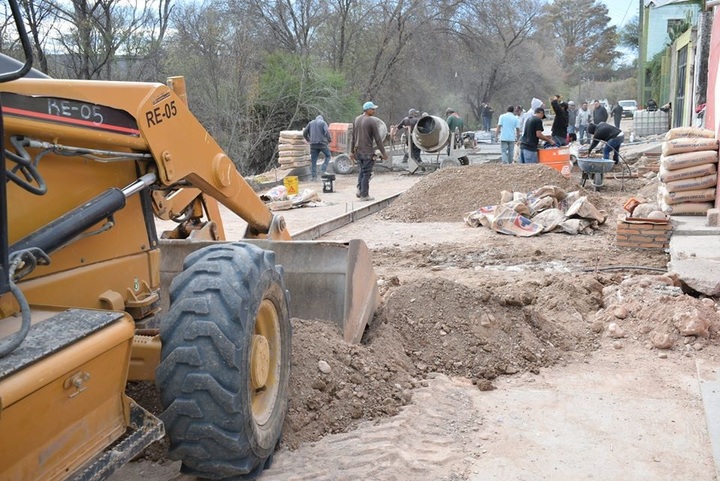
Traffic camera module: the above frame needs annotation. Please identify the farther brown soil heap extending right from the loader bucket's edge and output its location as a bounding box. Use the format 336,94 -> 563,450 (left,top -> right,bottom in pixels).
368,276 -> 602,380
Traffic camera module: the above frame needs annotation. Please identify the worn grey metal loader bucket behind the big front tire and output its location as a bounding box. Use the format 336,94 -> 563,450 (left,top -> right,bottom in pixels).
160,239 -> 380,343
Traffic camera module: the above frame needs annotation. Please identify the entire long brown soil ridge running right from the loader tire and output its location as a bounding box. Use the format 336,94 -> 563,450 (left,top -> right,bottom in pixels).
283,275 -> 604,449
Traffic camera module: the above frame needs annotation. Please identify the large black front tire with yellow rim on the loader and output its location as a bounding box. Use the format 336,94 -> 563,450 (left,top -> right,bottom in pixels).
156,243 -> 291,480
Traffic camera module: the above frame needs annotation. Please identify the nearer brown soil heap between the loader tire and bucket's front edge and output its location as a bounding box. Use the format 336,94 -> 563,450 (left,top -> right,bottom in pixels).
283,319 -> 418,449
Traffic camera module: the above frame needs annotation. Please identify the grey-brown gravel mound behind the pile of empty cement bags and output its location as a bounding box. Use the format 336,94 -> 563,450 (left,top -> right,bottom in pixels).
379,163 -> 608,222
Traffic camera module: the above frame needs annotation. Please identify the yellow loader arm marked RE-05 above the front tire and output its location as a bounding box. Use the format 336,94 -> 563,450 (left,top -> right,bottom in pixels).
2,79 -> 290,240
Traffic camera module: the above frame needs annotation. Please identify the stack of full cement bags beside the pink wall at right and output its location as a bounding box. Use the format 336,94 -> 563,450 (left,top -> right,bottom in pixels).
658,127 -> 718,215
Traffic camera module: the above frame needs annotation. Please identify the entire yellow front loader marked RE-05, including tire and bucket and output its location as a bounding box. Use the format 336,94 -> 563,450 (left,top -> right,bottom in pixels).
0,0 -> 378,481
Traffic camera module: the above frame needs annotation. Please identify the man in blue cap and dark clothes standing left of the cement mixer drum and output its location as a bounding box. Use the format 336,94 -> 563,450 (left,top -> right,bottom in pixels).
350,102 -> 387,202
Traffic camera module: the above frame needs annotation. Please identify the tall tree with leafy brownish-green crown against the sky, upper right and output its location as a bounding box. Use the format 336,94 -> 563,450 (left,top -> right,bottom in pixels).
543,0 -> 620,85
